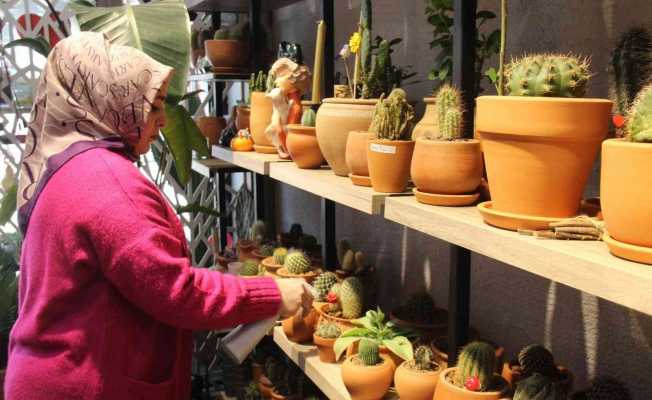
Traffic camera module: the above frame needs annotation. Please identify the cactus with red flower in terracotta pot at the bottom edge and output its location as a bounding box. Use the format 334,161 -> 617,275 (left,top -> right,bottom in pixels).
434,342 -> 509,400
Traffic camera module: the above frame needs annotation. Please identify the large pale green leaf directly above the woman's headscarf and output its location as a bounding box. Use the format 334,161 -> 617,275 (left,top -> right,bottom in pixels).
70,0 -> 190,97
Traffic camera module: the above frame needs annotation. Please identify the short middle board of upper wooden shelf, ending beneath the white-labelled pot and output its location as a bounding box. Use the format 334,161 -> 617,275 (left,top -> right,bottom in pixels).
269,163 -> 408,215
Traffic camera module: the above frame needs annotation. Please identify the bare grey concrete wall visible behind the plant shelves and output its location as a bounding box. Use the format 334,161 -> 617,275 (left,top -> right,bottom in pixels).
273,0 -> 652,400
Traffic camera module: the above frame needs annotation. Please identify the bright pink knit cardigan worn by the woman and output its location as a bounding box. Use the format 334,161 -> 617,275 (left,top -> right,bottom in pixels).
5,148 -> 280,400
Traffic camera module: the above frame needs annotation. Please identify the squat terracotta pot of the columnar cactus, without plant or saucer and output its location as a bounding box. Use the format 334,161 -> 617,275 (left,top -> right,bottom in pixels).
410,139 -> 482,195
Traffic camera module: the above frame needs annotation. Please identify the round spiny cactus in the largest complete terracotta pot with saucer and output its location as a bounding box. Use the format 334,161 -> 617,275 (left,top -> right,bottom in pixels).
476,54 -> 612,230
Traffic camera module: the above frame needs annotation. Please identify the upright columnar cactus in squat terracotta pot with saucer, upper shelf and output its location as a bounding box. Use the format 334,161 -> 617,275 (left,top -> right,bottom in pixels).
410,85 -> 483,206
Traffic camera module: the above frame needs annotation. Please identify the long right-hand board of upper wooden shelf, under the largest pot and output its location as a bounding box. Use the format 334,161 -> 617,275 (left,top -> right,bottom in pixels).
385,197 -> 652,315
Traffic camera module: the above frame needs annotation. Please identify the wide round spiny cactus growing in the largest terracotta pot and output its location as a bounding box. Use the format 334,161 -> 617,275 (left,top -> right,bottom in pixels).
505,54 -> 591,97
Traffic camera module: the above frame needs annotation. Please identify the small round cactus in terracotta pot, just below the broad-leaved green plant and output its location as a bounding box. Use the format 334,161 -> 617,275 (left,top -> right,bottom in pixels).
342,339 -> 394,400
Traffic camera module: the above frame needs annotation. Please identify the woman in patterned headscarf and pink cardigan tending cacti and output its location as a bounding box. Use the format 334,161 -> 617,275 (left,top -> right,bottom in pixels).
5,33 -> 312,400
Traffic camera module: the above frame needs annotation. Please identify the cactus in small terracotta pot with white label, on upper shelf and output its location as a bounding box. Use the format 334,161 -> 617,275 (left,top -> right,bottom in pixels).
367,89 -> 414,193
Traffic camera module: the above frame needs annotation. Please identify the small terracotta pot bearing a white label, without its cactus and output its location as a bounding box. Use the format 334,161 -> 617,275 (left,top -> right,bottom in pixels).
367,139 -> 414,193
